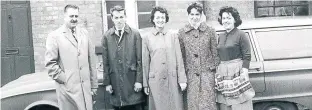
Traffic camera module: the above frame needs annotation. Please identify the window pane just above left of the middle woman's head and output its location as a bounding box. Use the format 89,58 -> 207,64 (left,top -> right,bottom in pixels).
137,0 -> 156,12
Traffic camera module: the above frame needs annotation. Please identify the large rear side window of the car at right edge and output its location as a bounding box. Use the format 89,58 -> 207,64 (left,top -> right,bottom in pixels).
256,28 -> 312,60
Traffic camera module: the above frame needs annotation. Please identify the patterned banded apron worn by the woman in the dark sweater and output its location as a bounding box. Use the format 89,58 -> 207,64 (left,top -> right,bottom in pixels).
215,59 -> 255,105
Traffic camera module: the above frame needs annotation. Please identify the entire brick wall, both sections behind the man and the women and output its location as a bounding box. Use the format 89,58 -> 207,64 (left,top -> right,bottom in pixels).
30,0 -> 254,72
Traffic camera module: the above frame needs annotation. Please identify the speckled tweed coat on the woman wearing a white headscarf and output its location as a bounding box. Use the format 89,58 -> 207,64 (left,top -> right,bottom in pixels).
178,22 -> 219,110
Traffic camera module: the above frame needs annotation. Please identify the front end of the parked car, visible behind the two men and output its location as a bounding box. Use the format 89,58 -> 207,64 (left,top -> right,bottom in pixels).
0,72 -> 107,110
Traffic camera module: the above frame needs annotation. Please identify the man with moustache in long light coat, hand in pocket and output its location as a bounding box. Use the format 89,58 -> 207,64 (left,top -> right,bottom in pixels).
45,5 -> 98,110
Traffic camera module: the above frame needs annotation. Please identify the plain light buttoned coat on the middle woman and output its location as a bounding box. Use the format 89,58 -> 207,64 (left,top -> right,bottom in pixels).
142,28 -> 186,110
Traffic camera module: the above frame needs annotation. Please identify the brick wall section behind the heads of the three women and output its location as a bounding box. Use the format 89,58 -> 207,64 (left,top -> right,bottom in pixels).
158,0 -> 254,29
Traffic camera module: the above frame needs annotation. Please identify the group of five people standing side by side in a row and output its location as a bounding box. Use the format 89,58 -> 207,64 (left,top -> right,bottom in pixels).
45,2 -> 255,110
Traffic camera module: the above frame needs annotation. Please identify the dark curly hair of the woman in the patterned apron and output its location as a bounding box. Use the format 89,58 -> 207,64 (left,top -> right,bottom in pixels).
218,6 -> 243,27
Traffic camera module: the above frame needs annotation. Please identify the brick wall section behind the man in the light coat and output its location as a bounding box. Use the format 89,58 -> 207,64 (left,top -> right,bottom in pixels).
30,0 -> 102,72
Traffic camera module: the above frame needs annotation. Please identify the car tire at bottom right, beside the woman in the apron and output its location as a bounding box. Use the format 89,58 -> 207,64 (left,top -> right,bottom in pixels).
254,102 -> 298,110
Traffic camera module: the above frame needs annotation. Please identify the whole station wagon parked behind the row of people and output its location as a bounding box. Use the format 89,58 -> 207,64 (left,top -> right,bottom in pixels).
1,17 -> 312,110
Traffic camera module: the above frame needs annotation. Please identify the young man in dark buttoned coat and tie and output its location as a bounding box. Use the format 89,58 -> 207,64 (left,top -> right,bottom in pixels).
102,6 -> 144,110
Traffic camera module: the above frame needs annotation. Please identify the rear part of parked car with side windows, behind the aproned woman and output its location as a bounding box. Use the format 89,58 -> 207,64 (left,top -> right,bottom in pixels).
210,17 -> 312,110
